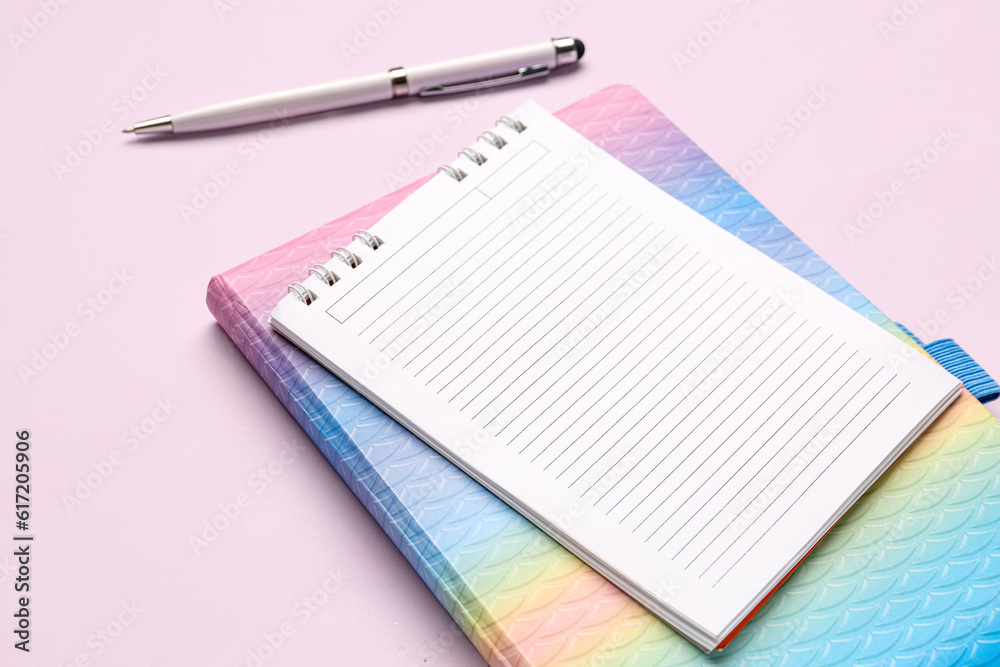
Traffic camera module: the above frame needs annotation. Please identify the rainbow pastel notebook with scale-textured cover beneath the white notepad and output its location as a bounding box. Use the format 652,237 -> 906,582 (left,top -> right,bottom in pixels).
208,86 -> 1000,667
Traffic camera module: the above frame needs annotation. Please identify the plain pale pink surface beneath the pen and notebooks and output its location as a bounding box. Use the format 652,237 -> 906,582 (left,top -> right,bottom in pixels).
0,0 -> 1000,667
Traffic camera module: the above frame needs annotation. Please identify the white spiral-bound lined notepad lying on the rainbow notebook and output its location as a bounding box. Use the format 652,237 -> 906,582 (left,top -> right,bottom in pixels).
271,103 -> 960,650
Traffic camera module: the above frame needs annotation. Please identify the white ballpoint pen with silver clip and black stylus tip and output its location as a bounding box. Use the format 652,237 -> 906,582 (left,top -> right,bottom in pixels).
122,37 -> 583,134
